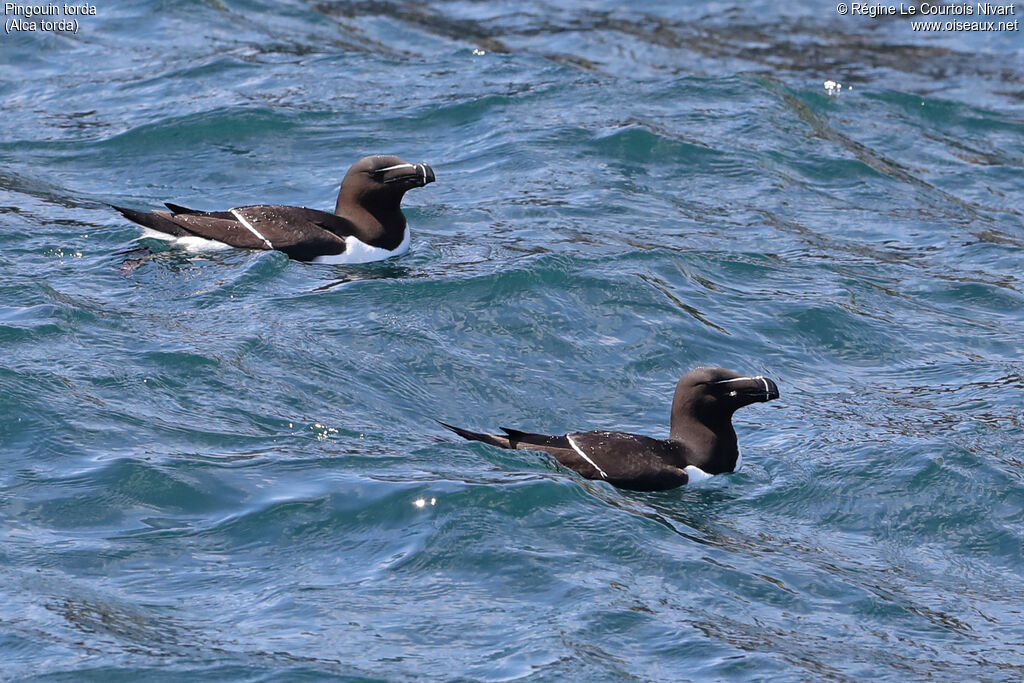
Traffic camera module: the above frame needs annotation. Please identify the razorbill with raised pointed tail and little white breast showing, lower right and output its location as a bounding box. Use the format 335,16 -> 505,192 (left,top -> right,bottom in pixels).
440,368 -> 778,490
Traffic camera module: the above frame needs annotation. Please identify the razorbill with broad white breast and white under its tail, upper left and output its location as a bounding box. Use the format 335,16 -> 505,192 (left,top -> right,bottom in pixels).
114,155 -> 434,263
